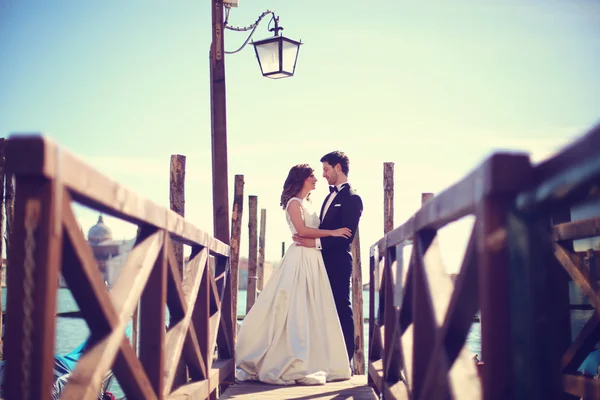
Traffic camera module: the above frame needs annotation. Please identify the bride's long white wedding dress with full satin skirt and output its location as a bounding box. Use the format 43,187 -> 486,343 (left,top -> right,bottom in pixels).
235,198 -> 351,385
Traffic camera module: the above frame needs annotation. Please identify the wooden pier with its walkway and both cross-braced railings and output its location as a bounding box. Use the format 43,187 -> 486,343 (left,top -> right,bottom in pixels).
2,120 -> 600,400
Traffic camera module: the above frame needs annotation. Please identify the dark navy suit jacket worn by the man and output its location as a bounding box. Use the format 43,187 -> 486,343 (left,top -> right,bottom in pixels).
319,184 -> 363,271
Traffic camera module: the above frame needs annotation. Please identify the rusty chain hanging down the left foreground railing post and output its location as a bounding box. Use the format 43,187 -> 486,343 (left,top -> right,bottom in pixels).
21,199 -> 41,399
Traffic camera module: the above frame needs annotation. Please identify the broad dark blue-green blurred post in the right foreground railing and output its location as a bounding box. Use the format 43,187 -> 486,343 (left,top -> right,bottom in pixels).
504,211 -> 561,399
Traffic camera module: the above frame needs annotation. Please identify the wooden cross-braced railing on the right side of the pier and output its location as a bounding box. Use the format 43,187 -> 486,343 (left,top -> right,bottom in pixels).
369,123 -> 600,399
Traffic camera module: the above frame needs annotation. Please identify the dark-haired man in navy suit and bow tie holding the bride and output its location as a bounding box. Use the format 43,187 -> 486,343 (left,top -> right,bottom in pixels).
294,151 -> 363,361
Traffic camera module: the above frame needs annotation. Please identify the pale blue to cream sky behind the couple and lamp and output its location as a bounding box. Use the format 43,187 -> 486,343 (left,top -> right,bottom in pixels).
0,0 -> 600,273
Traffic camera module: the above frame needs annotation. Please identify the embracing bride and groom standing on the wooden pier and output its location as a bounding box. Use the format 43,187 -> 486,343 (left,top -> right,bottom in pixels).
235,151 -> 363,385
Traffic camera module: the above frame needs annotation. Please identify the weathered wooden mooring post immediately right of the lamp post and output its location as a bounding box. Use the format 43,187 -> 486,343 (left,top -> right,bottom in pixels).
229,175 -> 244,324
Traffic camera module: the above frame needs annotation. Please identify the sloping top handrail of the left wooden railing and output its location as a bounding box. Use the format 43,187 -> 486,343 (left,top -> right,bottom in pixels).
6,135 -> 229,255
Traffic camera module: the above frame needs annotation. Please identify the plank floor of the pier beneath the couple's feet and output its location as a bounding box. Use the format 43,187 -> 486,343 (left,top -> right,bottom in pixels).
219,375 -> 377,400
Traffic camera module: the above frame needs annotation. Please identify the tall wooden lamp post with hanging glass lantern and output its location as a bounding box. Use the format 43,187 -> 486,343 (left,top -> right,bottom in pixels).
210,0 -> 301,244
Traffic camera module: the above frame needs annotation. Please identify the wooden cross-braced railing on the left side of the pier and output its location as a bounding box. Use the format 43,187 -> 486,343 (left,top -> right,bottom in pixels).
4,136 -> 235,400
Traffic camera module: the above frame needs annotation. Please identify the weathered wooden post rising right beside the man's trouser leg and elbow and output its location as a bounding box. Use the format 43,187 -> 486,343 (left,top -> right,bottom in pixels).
351,227 -> 365,375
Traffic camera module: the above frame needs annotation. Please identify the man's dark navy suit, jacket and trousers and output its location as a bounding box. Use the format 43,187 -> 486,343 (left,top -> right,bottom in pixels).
319,183 -> 363,360
